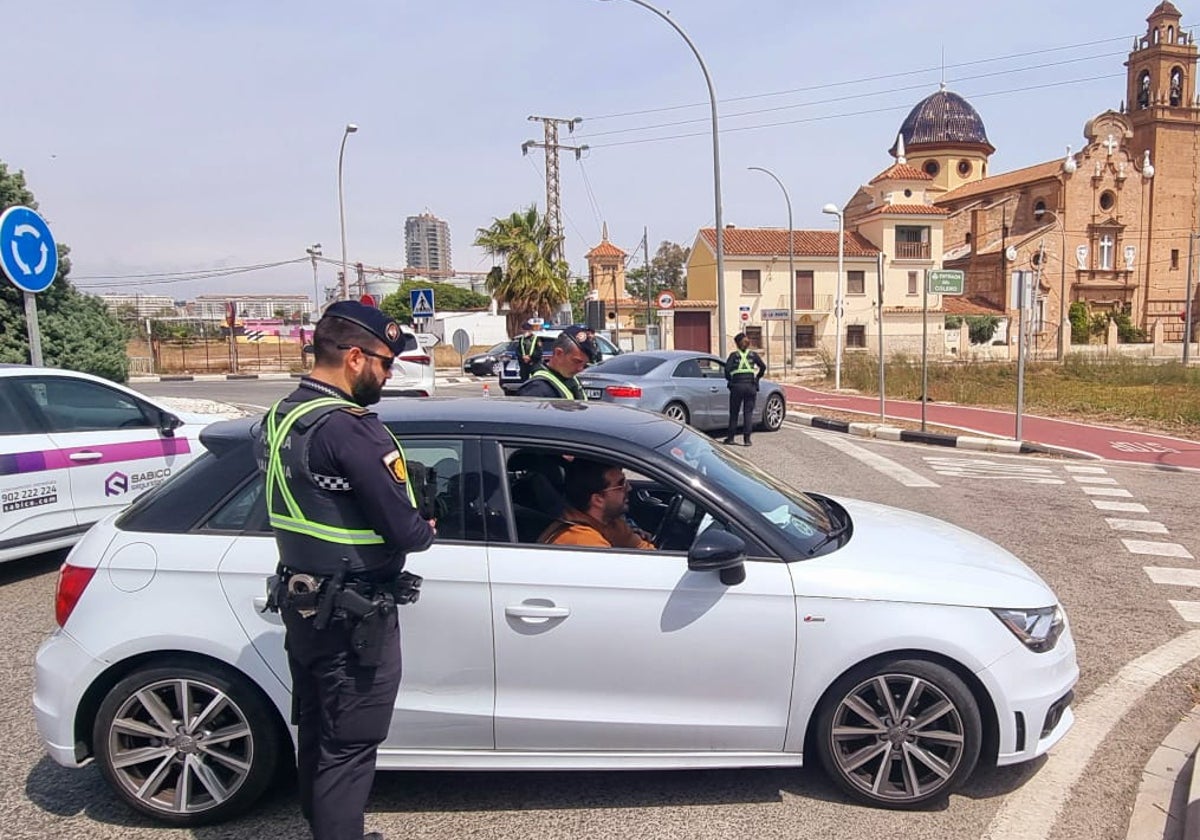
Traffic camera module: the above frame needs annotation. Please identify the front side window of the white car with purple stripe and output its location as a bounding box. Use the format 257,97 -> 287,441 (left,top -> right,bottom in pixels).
19,377 -> 157,433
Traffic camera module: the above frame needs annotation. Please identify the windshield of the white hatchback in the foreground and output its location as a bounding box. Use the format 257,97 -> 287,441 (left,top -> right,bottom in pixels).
658,431 -> 838,553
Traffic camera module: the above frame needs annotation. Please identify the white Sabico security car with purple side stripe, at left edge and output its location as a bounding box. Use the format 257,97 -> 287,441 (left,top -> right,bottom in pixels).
0,365 -> 222,562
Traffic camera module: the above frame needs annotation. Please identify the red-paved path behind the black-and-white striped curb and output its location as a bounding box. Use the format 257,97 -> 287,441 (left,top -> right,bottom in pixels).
784,384 -> 1200,469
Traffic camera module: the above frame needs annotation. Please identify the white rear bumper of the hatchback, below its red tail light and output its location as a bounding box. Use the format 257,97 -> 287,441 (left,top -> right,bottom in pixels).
34,630 -> 104,767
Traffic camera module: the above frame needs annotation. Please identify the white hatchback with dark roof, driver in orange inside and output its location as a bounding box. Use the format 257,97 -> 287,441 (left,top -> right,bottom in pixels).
34,398 -> 1079,824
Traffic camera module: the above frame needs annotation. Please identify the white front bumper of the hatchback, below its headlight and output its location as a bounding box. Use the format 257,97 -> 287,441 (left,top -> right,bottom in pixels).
978,626 -> 1079,764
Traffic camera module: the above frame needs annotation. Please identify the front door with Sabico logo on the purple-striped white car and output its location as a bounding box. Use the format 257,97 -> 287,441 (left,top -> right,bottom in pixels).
18,374 -> 198,526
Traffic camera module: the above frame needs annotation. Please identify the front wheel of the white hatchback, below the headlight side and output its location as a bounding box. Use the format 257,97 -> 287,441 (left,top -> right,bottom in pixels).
816,660 -> 983,808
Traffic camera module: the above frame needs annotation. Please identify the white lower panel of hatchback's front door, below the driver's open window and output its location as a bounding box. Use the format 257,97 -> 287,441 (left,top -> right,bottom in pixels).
487,444 -> 796,752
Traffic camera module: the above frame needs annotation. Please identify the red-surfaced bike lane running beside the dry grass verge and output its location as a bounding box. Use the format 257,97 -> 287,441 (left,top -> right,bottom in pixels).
784,385 -> 1200,469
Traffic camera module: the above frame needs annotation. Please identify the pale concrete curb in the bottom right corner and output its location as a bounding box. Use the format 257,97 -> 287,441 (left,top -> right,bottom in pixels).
1126,706 -> 1200,840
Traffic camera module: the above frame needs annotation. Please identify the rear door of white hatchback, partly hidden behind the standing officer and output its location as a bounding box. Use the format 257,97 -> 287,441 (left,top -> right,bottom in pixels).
218,439 -> 494,750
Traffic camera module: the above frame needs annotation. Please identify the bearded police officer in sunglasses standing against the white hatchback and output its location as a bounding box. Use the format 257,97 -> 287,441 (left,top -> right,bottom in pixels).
259,301 -> 436,840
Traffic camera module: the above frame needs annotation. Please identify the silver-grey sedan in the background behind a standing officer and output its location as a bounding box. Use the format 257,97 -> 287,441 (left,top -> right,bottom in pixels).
578,350 -> 787,432
